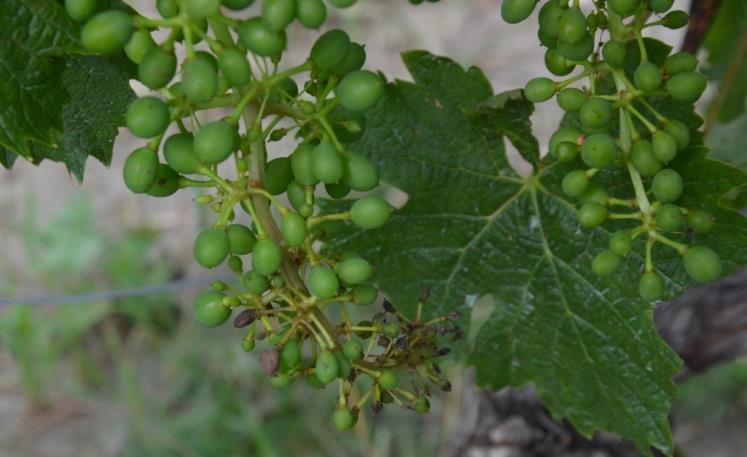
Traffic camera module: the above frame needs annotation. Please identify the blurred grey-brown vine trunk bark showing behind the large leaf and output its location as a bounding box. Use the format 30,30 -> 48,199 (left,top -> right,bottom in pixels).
449,269 -> 747,457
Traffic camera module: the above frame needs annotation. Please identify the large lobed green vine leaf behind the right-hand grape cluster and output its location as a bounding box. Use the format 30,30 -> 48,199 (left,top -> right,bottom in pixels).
329,52 -> 747,455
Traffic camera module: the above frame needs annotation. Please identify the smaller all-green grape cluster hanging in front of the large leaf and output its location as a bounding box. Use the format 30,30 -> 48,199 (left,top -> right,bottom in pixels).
501,0 -> 721,300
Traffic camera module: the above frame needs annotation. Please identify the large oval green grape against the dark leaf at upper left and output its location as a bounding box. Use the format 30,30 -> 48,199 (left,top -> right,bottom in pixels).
80,10 -> 132,55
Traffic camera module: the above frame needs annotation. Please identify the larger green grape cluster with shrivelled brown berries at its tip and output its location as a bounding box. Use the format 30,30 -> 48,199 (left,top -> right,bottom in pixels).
66,0 -> 452,430
